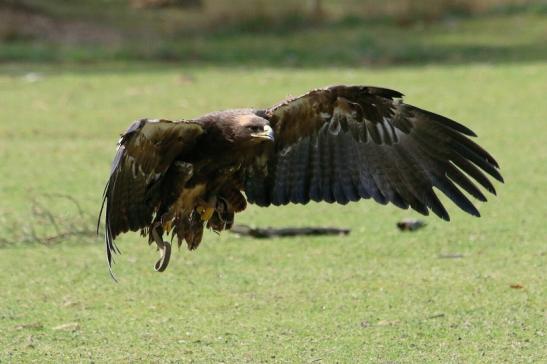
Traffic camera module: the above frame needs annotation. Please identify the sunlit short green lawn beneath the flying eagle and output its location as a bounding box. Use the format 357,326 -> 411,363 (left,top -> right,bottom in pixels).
0,63 -> 547,363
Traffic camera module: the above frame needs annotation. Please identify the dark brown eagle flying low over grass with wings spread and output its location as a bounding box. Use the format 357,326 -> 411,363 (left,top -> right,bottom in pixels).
97,85 -> 503,274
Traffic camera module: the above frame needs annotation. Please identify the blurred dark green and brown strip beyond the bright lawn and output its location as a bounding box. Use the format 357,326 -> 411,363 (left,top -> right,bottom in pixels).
0,0 -> 547,67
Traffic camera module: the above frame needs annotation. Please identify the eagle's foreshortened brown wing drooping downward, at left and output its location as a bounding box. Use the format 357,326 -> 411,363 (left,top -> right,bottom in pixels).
97,119 -> 203,265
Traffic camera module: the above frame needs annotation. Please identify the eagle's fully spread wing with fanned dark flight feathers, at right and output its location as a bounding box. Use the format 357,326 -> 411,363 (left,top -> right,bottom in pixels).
245,86 -> 503,220
